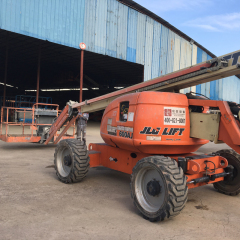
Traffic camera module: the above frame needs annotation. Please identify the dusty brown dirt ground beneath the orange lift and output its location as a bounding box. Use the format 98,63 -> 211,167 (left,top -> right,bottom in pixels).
0,124 -> 240,240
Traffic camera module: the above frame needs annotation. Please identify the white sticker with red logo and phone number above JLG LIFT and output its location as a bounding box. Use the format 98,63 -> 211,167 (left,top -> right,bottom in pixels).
163,107 -> 186,126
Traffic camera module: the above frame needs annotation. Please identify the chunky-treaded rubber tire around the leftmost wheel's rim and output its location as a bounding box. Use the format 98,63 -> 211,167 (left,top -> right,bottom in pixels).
54,139 -> 90,183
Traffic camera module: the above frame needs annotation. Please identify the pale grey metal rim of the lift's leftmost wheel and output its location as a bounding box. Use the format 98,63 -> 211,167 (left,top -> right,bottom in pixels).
57,147 -> 72,177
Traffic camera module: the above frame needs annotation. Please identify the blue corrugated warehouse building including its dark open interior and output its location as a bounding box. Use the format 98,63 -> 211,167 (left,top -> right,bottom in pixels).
0,0 -> 239,107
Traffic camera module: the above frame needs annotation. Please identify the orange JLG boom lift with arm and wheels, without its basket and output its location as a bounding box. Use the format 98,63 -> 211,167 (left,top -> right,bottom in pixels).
2,51 -> 240,221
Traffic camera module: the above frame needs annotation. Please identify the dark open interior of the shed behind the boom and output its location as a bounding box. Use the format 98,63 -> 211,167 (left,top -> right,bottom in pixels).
0,30 -> 143,107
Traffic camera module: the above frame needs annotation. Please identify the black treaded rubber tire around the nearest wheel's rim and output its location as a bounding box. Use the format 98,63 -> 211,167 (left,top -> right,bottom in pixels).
130,156 -> 188,222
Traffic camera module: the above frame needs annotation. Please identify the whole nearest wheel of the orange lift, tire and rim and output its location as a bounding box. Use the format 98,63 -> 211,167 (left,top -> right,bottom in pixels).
131,156 -> 188,221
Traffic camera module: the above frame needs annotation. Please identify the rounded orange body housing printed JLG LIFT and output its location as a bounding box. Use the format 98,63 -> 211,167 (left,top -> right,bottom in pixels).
100,92 -> 208,155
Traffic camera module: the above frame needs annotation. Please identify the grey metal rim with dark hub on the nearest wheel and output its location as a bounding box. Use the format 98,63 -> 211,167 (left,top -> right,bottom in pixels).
135,166 -> 166,212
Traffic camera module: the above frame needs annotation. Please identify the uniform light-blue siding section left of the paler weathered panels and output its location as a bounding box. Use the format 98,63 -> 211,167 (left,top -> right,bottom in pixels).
7,0 -> 85,47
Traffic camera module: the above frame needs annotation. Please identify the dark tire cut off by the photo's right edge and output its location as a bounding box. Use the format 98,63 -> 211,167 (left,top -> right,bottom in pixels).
213,149 -> 240,196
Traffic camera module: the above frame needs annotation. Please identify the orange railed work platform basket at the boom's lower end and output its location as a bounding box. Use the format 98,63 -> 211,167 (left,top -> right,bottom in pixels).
0,103 -> 75,143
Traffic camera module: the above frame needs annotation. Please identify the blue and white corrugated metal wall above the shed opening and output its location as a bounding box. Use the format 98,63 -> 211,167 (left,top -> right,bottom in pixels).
0,0 -> 240,102
